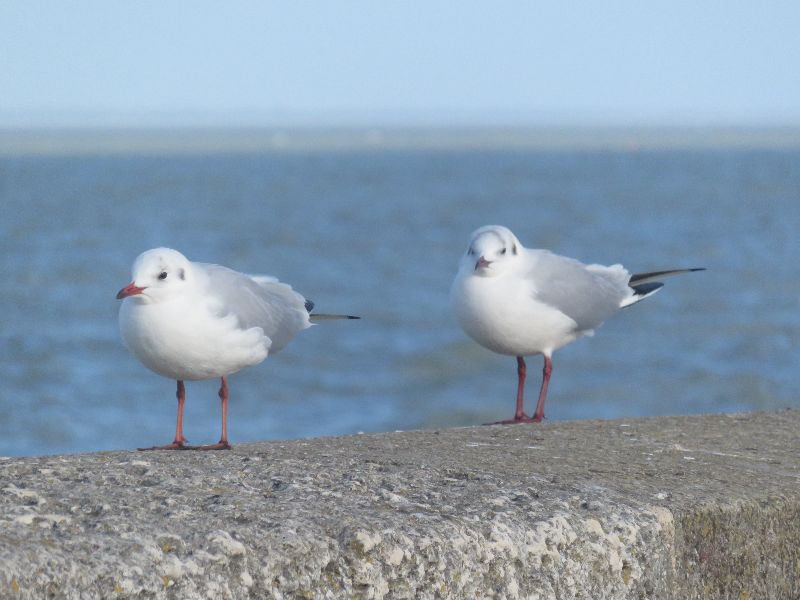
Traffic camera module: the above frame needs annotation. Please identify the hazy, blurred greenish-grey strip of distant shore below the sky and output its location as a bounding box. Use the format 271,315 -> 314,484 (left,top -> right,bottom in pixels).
0,126 -> 800,157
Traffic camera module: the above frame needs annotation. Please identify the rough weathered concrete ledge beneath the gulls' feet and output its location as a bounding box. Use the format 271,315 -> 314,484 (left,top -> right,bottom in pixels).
0,411 -> 800,600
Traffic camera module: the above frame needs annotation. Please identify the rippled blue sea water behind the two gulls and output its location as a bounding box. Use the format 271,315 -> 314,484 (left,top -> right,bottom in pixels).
0,134 -> 800,455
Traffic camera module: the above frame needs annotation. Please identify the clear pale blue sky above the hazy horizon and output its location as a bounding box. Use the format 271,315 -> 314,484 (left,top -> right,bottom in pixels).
0,0 -> 800,128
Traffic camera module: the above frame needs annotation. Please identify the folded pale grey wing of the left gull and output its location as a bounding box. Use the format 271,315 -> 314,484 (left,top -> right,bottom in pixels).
202,265 -> 310,353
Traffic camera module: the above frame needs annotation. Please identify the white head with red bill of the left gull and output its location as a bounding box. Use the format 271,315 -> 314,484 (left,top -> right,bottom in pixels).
117,248 -> 191,302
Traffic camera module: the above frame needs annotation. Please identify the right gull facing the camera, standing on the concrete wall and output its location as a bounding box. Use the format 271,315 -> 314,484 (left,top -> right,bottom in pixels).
450,225 -> 705,424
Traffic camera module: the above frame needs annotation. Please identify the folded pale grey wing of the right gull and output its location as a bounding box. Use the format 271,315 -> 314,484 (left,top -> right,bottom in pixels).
530,250 -> 632,331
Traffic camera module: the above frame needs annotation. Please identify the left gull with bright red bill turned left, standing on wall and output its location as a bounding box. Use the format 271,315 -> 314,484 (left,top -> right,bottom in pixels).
117,248 -> 359,450
